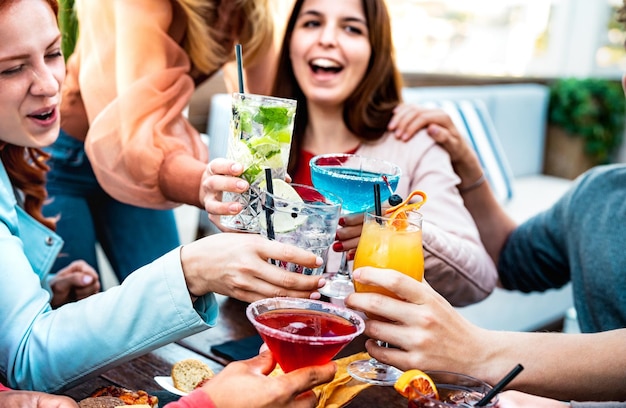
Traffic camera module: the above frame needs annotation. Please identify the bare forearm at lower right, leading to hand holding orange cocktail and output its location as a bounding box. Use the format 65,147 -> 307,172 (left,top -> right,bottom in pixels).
474,329 -> 626,401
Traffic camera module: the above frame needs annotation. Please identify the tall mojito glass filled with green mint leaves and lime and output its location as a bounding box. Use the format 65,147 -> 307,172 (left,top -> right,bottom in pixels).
220,93 -> 296,232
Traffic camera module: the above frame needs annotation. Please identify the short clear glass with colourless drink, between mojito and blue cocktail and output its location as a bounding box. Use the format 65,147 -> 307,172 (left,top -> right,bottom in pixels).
259,184 -> 341,275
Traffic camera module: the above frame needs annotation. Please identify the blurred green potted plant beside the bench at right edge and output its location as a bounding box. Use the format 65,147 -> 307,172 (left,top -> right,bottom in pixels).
544,78 -> 626,178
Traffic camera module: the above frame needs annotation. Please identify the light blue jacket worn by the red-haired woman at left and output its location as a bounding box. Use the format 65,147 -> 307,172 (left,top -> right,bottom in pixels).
0,161 -> 218,392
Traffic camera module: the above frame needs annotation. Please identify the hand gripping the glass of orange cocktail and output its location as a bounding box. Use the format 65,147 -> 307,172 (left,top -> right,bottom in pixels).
346,267 -> 488,378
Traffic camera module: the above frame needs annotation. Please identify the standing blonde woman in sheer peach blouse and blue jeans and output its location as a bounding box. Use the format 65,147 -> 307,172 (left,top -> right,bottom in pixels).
44,0 -> 276,281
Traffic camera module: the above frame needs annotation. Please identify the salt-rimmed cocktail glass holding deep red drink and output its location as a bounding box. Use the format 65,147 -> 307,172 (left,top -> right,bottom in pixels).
246,297 -> 365,373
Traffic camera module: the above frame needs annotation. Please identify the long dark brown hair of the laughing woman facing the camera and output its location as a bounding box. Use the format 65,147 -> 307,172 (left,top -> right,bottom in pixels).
272,0 -> 402,174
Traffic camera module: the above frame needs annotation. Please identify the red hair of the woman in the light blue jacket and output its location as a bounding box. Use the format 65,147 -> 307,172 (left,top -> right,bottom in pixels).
0,0 -> 59,230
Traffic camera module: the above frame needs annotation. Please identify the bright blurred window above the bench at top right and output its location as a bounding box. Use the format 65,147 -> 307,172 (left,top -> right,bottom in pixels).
387,0 -> 626,77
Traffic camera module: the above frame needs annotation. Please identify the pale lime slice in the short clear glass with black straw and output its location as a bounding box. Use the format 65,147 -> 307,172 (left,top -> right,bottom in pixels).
259,179 -> 307,233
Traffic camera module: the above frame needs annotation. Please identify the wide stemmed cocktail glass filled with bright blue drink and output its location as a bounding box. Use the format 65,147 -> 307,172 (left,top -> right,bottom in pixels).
309,154 -> 402,299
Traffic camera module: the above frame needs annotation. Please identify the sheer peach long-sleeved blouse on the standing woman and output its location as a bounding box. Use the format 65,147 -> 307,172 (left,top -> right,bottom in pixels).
61,0 -> 208,208
